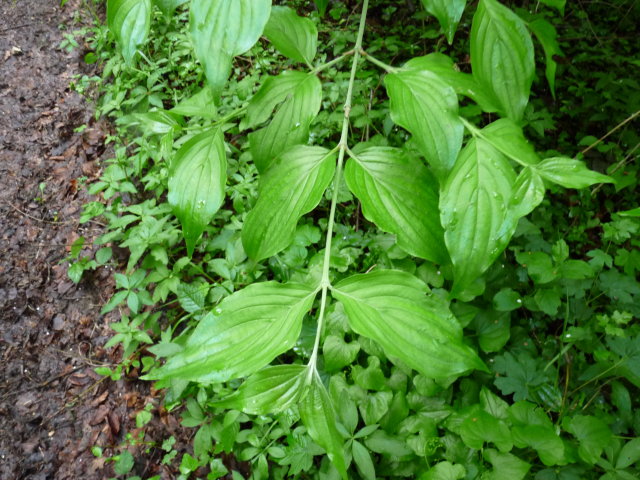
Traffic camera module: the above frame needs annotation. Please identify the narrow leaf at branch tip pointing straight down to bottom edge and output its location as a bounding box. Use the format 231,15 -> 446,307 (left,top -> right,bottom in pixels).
299,370 -> 348,480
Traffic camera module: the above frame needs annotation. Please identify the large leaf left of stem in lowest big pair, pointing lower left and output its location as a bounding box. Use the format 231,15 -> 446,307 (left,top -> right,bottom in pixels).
146,282 -> 316,382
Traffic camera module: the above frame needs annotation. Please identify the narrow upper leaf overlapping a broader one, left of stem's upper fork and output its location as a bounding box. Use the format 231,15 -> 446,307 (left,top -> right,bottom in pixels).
240,70 -> 309,129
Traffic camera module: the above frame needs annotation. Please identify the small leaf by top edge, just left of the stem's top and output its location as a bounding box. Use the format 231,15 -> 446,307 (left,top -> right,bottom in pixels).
264,7 -> 318,66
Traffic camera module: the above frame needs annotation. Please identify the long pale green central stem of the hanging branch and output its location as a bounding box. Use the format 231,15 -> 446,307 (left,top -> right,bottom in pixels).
307,0 -> 369,383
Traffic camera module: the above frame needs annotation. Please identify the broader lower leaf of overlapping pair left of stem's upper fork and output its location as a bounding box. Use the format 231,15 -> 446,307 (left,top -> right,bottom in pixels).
249,75 -> 322,172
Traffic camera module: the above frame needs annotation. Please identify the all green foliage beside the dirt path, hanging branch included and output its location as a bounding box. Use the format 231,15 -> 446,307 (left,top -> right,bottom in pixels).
69,0 -> 640,480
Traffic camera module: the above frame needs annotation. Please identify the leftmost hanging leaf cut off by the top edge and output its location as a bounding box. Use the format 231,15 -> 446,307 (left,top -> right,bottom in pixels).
107,0 -> 151,64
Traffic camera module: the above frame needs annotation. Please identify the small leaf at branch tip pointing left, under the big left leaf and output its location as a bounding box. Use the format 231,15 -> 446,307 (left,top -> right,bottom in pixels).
217,365 -> 307,415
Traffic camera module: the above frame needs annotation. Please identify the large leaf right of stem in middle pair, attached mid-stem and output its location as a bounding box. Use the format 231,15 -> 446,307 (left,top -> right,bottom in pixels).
344,147 -> 449,263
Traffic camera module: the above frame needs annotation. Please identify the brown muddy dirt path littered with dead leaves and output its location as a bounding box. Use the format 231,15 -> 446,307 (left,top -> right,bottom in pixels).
0,0 -> 188,480
